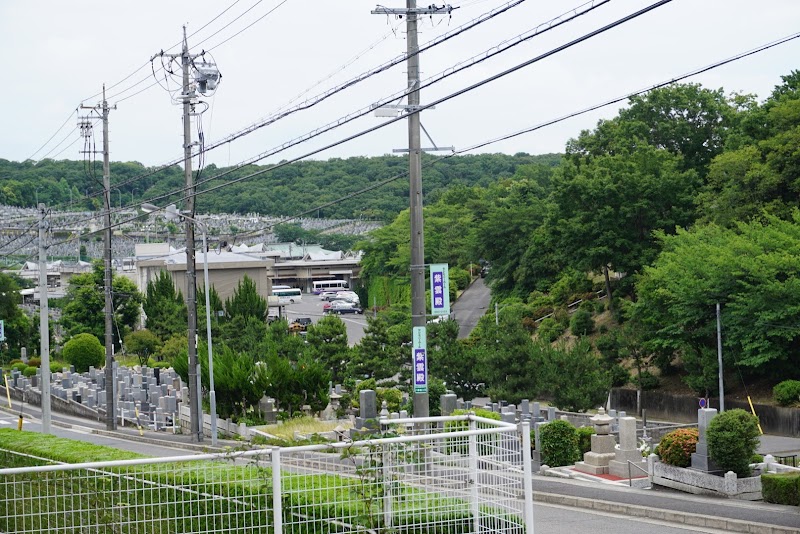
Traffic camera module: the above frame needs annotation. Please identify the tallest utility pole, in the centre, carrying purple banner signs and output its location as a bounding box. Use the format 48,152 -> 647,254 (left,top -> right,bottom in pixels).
372,0 -> 453,417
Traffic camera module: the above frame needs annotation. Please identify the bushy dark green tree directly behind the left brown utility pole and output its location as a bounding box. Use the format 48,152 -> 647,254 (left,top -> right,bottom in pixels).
61,262 -> 142,348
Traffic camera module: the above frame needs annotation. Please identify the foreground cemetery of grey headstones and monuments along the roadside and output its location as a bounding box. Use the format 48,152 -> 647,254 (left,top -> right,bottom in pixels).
3,364 -> 800,508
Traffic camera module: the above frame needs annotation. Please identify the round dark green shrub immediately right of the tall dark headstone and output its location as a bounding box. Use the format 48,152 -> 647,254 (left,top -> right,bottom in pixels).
706,409 -> 761,477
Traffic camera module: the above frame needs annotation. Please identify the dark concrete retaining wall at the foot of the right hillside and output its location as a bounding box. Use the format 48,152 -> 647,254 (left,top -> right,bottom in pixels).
611,388 -> 800,437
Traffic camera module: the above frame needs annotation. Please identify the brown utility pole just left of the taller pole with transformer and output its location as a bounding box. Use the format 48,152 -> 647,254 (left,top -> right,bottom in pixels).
78,84 -> 117,430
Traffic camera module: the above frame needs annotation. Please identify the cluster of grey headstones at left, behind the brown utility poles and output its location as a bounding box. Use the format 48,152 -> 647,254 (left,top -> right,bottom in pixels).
11,364 -> 188,427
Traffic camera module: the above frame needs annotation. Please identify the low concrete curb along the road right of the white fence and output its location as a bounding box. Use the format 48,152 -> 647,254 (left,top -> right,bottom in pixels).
533,491 -> 800,534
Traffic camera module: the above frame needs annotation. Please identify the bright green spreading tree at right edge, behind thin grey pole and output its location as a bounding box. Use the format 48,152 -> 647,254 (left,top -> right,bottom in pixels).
632,212 -> 800,395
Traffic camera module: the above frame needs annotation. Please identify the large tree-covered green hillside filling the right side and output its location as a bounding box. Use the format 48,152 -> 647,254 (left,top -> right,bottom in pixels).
360,72 -> 800,398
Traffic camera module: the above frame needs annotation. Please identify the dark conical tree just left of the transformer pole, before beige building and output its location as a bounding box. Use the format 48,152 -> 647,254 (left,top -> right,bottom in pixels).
142,271 -> 188,341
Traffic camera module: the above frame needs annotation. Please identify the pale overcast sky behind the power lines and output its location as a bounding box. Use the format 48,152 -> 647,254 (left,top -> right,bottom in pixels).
0,0 -> 800,170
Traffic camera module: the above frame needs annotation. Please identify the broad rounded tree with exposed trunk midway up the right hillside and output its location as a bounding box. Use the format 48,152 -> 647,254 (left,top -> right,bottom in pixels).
548,146 -> 697,308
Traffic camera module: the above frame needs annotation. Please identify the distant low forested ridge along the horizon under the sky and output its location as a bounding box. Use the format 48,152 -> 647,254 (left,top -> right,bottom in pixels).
0,154 -> 560,221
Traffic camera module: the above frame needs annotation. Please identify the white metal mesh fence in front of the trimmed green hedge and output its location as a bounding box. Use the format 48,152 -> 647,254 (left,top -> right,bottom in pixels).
0,415 -> 533,534
